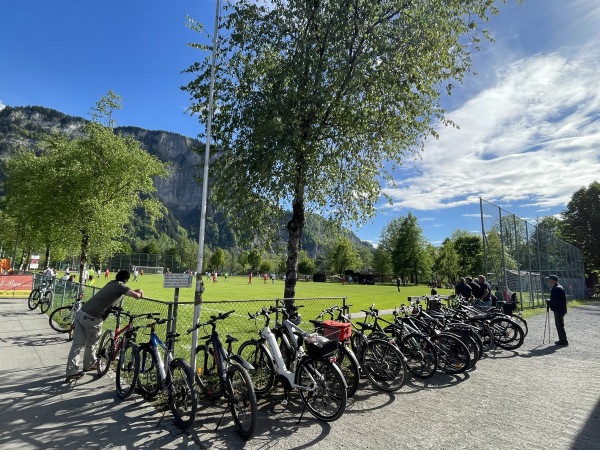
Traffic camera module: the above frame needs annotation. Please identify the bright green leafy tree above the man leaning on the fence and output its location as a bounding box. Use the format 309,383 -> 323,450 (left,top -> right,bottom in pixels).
41,93 -> 168,280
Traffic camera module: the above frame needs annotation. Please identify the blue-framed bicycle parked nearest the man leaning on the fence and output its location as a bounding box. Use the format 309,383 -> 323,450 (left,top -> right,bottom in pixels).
133,314 -> 197,430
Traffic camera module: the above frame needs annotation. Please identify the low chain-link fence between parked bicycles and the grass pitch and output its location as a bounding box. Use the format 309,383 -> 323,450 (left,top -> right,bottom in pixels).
34,275 -> 346,360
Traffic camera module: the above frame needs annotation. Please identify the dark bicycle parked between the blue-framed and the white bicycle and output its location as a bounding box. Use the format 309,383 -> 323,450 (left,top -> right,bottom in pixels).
187,311 -> 258,440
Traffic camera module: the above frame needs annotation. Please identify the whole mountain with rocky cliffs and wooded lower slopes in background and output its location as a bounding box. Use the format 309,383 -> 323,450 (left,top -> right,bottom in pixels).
0,106 -> 372,257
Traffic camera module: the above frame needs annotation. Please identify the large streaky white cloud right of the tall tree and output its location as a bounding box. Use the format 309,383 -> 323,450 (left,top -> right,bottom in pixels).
385,48 -> 600,210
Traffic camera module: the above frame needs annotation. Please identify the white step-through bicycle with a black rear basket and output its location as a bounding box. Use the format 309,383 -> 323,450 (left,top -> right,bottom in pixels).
238,306 -> 348,422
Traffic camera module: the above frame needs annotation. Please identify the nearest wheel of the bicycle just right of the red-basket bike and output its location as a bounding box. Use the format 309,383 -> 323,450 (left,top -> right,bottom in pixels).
361,339 -> 406,392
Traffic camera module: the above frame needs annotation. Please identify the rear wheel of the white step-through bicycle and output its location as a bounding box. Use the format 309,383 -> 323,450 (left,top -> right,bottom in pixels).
295,358 -> 348,422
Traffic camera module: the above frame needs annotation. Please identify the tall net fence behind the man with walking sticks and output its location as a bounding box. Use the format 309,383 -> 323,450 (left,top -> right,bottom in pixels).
480,200 -> 586,307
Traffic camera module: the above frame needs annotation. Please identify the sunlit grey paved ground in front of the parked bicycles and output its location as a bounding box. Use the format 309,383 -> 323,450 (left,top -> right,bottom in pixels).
0,299 -> 600,450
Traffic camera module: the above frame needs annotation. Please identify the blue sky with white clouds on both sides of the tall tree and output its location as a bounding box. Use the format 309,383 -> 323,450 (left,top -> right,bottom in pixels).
0,0 -> 600,244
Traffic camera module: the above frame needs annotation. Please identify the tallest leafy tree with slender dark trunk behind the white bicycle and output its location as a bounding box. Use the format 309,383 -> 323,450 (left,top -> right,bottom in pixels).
183,0 -> 506,298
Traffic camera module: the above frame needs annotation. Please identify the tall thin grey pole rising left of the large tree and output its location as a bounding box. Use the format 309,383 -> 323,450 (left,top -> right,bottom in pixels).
190,0 -> 221,373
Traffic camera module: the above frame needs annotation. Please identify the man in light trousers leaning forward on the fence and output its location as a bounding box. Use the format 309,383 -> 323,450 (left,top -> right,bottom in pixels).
65,270 -> 144,383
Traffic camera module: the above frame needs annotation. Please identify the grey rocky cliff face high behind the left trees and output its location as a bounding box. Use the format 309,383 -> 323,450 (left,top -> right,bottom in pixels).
0,106 -> 202,226
